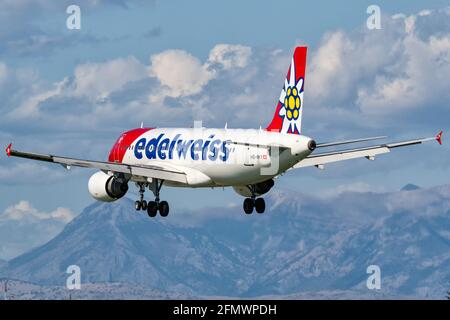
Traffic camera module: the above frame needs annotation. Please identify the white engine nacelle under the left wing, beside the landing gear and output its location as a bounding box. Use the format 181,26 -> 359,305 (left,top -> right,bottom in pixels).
88,171 -> 128,202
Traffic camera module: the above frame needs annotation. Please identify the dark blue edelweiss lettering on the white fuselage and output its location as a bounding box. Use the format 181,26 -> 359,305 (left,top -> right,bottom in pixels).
134,133 -> 230,161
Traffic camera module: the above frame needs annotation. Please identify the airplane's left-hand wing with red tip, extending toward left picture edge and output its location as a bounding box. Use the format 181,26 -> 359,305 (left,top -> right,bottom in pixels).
6,144 -> 187,183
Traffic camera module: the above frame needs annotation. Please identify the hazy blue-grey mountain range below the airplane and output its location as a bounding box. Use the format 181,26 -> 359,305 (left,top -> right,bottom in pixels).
0,185 -> 450,299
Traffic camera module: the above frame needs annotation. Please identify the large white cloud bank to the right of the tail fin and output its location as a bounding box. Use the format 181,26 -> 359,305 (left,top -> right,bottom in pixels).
307,10 -> 450,125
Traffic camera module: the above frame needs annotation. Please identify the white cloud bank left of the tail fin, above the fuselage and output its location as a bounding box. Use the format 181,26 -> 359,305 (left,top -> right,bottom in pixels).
0,45 -> 262,150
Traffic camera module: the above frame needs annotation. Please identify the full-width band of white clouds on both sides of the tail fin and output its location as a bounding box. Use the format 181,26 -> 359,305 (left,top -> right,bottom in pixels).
0,7 -> 450,144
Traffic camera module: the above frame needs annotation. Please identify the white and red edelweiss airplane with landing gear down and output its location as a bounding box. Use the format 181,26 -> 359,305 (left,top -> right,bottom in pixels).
6,47 -> 442,217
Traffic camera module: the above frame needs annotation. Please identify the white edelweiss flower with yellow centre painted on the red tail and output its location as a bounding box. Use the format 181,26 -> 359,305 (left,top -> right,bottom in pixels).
279,60 -> 303,133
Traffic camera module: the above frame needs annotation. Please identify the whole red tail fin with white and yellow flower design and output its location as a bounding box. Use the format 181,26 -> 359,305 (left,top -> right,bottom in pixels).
266,47 -> 307,134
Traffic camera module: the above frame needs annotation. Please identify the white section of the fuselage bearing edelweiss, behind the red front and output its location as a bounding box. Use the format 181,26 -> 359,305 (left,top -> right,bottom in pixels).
115,128 -> 311,187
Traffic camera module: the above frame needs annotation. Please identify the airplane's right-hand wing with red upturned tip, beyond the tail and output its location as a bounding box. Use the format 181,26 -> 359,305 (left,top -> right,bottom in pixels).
293,131 -> 442,169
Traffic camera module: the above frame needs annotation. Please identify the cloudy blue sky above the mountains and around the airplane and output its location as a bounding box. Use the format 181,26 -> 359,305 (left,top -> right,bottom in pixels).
0,0 -> 450,258
